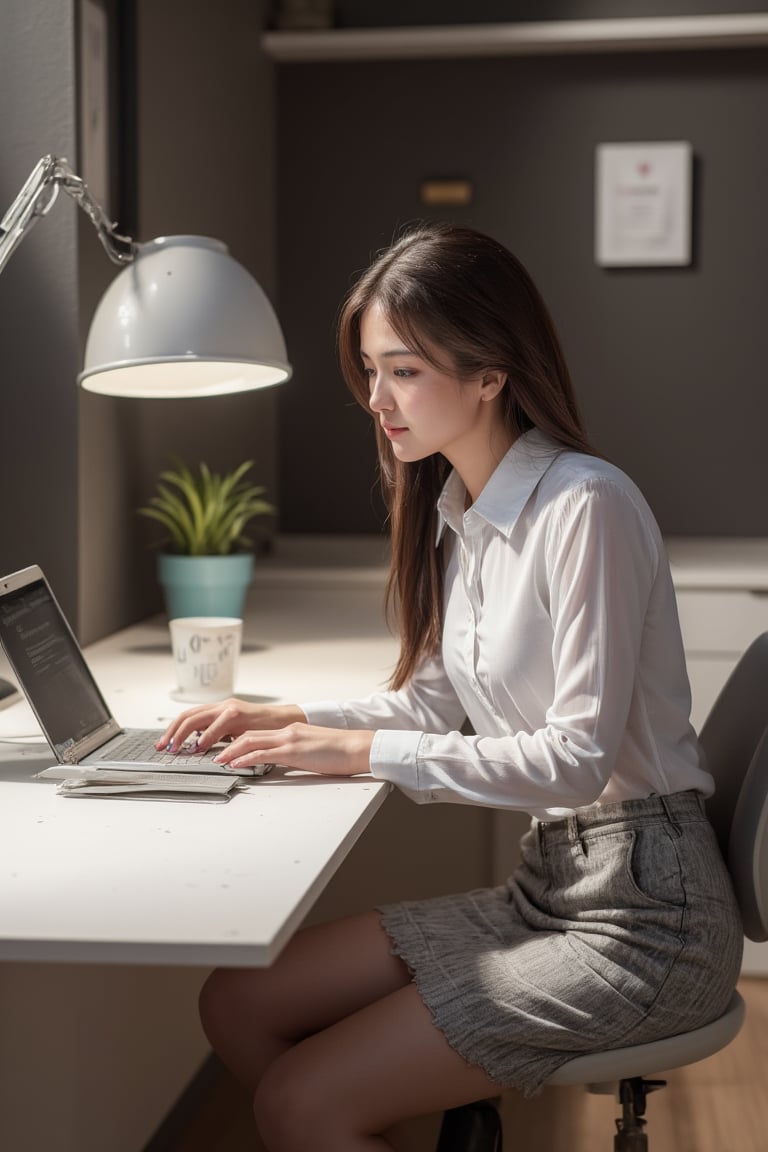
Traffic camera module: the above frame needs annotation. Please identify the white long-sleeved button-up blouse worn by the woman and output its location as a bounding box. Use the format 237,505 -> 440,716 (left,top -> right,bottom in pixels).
302,430 -> 713,820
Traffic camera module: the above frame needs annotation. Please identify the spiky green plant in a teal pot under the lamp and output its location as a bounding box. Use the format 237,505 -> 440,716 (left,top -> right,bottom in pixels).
138,460 -> 275,619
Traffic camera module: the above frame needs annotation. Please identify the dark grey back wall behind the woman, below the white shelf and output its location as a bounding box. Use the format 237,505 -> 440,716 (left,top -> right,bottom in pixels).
277,14 -> 768,536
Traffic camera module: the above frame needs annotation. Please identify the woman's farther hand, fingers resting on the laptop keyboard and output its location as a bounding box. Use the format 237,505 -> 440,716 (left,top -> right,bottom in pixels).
155,699 -> 306,752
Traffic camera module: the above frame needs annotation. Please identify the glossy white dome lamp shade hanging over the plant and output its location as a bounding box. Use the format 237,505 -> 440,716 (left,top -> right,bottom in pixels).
78,236 -> 291,399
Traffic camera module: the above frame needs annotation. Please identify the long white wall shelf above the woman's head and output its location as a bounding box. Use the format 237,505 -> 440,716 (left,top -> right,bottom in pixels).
261,13 -> 768,61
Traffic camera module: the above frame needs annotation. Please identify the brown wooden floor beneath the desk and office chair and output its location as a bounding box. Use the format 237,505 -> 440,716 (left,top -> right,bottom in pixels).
161,978 -> 768,1152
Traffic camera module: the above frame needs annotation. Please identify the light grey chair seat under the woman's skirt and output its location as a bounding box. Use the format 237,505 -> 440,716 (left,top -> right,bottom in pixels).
547,992 -> 745,1091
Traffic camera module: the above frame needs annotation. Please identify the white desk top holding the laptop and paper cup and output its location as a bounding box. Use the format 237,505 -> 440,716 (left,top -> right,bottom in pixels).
0,555 -> 395,965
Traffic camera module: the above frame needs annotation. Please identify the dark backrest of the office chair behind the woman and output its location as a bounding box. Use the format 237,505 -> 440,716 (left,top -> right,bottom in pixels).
699,632 -> 768,940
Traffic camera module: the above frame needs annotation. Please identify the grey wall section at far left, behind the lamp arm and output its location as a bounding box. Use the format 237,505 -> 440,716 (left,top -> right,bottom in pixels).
0,0 -> 79,615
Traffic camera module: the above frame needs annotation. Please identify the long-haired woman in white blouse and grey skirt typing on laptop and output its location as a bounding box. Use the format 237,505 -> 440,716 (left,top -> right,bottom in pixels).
158,225 -> 742,1152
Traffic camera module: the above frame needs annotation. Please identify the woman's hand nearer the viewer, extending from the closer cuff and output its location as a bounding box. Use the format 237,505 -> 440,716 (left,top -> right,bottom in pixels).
214,721 -> 373,776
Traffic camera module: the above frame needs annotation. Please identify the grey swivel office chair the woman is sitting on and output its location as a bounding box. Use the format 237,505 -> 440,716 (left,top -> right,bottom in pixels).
436,632 -> 768,1152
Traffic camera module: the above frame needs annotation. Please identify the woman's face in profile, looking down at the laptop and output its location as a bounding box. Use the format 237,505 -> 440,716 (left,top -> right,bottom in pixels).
360,304 -> 503,472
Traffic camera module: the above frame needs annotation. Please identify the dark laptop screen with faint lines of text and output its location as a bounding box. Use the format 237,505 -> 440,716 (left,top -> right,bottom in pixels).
0,569 -> 112,753
